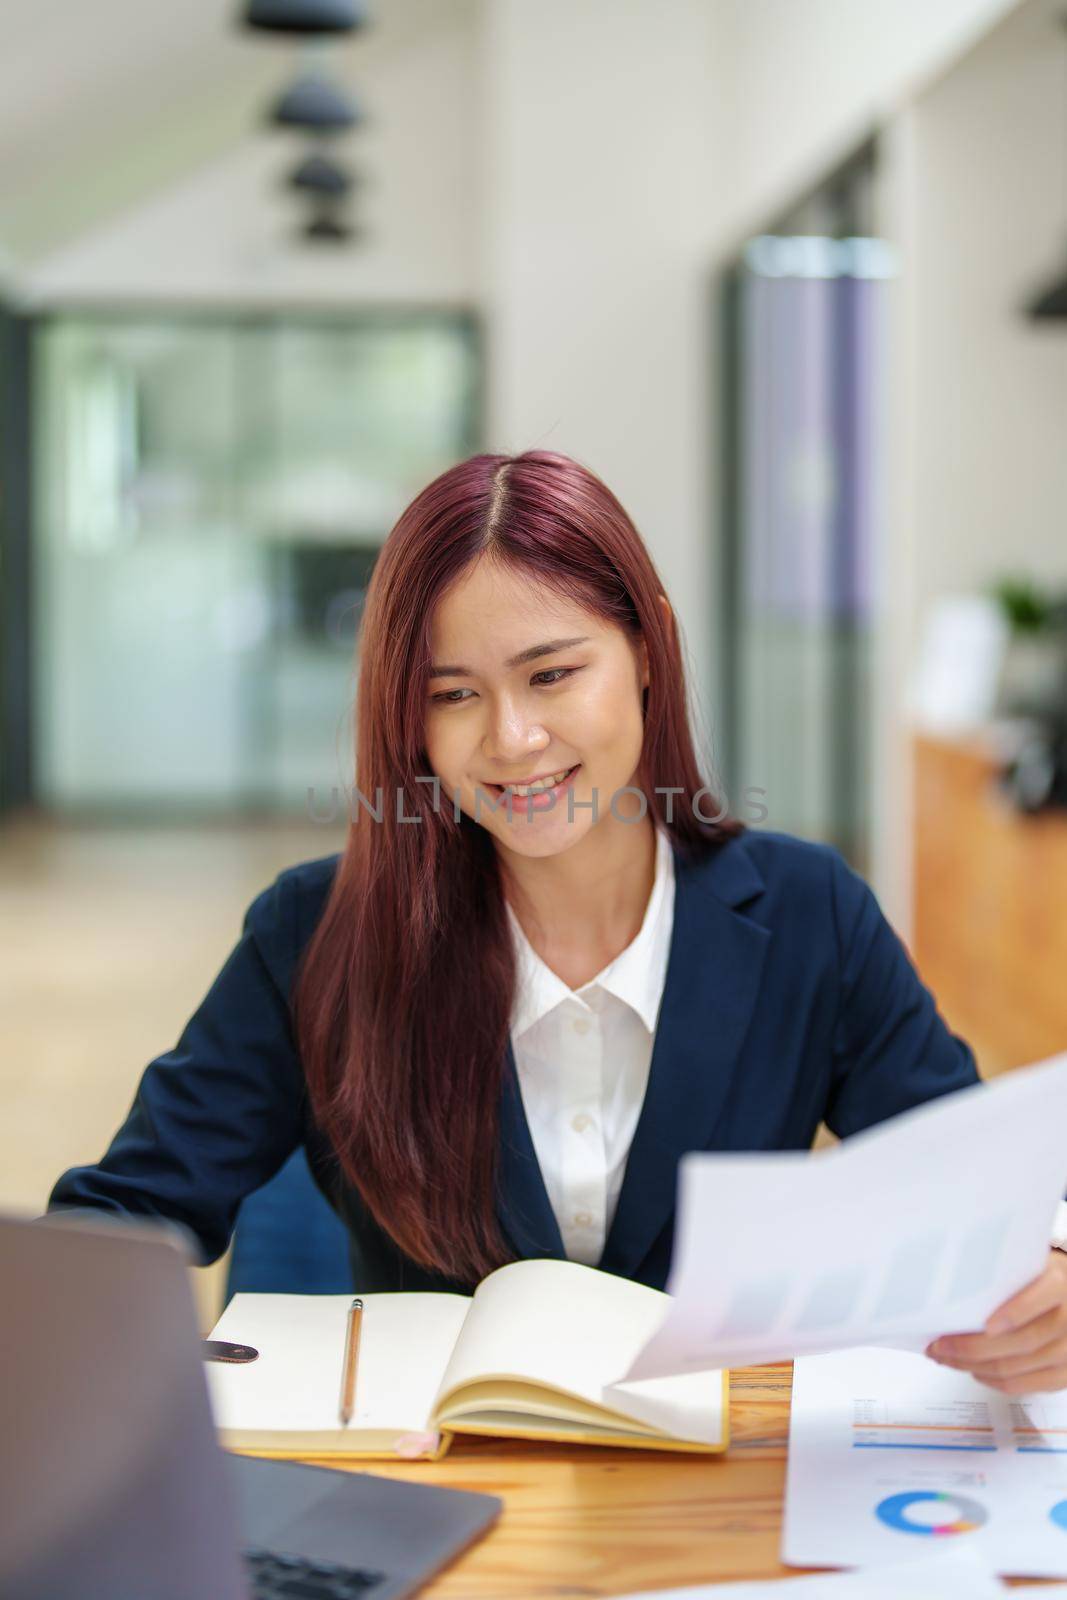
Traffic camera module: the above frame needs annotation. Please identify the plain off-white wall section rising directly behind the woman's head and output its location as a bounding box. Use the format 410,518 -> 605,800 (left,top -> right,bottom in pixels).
485,0 -> 720,774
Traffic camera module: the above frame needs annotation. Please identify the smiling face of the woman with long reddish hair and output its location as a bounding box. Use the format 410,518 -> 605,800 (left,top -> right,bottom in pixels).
426,557 -> 648,856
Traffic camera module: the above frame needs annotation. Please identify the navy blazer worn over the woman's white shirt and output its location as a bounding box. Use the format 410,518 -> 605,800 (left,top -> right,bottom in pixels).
50,830 -> 977,1293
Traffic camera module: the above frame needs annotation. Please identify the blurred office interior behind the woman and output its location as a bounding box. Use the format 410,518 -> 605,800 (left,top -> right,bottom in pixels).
0,0 -> 1067,1305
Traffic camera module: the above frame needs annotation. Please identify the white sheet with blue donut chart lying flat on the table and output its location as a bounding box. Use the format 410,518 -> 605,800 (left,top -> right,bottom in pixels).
782,1347 -> 1067,1594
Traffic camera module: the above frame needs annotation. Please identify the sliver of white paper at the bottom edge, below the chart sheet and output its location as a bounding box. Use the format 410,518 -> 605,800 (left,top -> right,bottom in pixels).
622,1546 -> 1004,1600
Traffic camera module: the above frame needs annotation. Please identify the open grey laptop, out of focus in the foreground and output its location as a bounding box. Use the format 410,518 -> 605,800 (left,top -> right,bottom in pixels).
0,1213 -> 501,1600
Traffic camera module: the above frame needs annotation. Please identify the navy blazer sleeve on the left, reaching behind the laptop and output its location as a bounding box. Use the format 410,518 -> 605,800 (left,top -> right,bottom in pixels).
48,874 -> 306,1264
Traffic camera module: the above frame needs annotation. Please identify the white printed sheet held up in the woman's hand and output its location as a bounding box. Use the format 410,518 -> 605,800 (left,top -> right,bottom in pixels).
617,1054 -> 1067,1382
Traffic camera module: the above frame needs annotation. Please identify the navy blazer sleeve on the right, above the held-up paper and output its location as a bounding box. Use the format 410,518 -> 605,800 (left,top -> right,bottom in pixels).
824,851 -> 979,1138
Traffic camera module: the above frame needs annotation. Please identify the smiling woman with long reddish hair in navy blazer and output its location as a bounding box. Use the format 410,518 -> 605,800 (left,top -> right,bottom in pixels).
50,451 -> 1067,1389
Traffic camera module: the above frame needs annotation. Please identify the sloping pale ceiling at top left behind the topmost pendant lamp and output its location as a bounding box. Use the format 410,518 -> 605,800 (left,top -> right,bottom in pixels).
0,0 -> 472,277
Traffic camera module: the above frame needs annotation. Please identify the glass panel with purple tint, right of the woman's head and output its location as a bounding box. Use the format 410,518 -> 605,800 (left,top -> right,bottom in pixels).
721,152 -> 893,870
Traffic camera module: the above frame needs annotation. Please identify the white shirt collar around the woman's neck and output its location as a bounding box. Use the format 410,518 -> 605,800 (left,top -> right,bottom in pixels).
507,826 -> 675,1038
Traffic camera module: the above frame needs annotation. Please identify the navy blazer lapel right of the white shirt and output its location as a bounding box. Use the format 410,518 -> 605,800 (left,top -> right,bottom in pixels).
600,842 -> 769,1277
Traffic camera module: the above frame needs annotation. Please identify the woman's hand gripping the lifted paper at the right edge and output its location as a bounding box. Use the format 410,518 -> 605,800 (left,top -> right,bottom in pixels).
926,1250 -> 1067,1395
